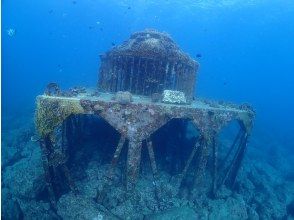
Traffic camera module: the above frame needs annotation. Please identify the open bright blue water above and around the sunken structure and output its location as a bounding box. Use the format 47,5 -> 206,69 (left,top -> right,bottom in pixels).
1,0 -> 294,218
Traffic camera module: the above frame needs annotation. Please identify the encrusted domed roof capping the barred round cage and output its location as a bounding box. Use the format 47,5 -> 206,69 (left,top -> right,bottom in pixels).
107,29 -> 197,67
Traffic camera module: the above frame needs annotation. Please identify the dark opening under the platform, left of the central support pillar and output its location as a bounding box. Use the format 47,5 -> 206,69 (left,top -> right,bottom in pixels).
65,115 -> 120,177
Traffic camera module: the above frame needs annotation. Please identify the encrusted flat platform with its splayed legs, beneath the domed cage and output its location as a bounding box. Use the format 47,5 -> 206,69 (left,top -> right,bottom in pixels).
36,90 -> 254,205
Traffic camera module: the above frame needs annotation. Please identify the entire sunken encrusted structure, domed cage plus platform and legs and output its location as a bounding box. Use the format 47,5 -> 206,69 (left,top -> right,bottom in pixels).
35,29 -> 255,206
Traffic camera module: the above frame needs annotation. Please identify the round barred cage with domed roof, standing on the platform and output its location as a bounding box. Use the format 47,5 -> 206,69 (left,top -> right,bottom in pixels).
98,29 -> 198,101
